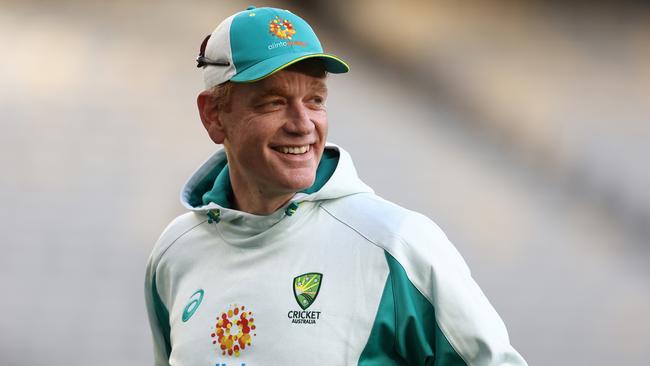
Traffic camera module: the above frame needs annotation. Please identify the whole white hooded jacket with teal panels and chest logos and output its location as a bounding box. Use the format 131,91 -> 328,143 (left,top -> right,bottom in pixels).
145,144 -> 526,366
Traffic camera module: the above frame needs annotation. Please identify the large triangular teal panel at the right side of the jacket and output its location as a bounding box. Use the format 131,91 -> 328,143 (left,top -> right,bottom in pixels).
359,253 -> 467,366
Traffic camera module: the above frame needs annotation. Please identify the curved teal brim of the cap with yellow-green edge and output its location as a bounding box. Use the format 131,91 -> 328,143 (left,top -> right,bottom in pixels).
230,52 -> 350,83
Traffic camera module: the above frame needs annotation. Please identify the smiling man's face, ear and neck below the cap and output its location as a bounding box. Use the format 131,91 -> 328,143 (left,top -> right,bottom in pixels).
198,56 -> 327,215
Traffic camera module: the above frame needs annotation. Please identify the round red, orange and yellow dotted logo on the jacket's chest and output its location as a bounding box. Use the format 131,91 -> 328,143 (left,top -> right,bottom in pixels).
210,304 -> 257,357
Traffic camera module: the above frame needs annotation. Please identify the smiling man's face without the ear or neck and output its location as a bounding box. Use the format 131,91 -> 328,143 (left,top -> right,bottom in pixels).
219,69 -> 327,197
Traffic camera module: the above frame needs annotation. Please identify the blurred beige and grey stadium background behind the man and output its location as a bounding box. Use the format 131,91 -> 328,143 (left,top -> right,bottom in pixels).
0,0 -> 650,366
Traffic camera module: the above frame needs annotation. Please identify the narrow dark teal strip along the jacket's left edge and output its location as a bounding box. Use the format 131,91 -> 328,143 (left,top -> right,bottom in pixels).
145,253 -> 171,366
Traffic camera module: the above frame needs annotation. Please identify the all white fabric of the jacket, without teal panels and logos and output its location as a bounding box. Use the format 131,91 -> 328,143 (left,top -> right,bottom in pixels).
145,144 -> 526,366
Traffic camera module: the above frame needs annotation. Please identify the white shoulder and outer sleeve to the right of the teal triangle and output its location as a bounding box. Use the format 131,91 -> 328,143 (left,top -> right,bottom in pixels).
322,195 -> 526,366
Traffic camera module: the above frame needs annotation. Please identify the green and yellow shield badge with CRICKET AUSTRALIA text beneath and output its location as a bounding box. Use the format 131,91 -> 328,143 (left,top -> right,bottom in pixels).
287,272 -> 323,324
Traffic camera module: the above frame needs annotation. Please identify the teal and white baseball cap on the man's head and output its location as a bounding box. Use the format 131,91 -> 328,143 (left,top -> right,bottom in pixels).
196,6 -> 350,89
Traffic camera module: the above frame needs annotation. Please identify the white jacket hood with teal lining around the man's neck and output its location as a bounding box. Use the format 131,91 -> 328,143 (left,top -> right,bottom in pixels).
181,142 -> 373,220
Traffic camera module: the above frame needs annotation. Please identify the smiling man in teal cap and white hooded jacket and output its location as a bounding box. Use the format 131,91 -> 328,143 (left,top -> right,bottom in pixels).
146,7 -> 525,366
